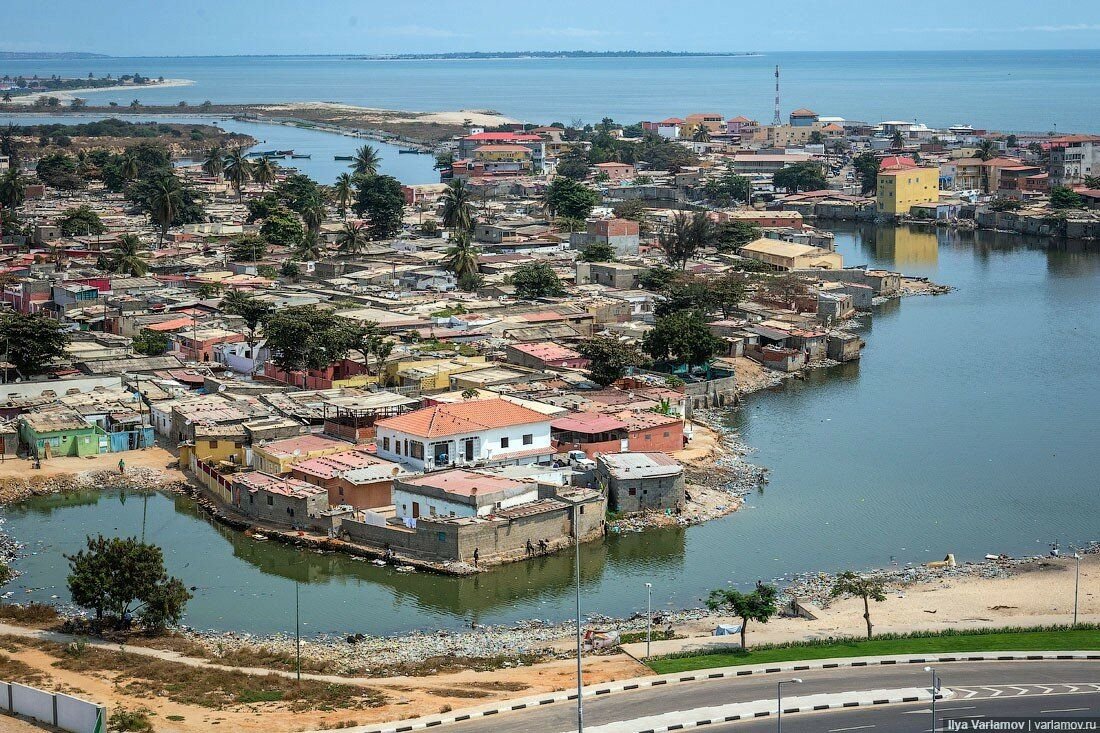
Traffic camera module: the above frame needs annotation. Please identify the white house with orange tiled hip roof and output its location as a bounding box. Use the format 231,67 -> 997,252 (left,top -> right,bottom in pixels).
375,400 -> 554,471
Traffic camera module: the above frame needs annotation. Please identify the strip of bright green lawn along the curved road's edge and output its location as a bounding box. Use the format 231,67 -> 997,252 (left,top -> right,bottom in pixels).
647,624 -> 1100,675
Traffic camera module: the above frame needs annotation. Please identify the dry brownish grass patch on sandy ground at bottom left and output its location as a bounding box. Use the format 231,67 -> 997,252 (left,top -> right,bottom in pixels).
35,642 -> 385,711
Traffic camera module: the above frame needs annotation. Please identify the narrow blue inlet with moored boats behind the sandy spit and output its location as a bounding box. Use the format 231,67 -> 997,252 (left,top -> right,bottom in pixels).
0,113 -> 439,185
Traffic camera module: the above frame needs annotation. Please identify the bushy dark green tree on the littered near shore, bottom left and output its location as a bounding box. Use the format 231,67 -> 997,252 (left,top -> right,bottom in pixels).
65,535 -> 191,632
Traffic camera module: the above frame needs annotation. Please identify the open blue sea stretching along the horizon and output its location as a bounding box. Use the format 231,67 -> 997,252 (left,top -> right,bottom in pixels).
0,51 -> 1100,132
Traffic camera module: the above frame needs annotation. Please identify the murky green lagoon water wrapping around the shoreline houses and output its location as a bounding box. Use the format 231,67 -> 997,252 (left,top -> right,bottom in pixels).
3,228 -> 1100,634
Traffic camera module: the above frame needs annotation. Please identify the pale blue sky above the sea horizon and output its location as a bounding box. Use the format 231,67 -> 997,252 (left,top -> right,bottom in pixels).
0,0 -> 1100,56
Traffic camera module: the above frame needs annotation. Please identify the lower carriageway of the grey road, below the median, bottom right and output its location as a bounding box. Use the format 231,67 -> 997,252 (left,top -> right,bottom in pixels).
699,689 -> 1100,733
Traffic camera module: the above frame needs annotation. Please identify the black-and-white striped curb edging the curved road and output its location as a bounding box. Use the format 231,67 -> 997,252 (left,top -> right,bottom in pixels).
352,652 -> 1100,733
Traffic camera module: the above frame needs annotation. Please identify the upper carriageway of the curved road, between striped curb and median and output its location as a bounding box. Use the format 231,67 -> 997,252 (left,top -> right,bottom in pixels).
447,661 -> 1100,733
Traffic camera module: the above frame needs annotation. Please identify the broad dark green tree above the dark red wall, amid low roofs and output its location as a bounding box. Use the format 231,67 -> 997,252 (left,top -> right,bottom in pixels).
264,306 -> 361,371
